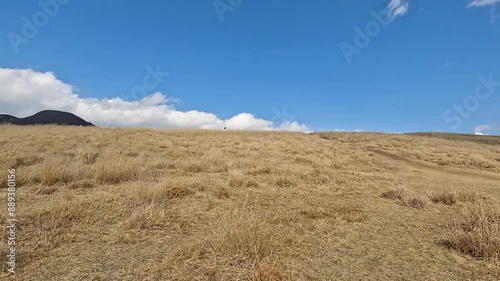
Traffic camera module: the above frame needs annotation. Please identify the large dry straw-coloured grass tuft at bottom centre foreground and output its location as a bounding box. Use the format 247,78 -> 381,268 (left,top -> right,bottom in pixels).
168,208 -> 289,280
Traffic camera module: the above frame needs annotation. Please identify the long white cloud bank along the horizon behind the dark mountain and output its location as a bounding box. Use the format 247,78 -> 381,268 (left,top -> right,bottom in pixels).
0,68 -> 310,132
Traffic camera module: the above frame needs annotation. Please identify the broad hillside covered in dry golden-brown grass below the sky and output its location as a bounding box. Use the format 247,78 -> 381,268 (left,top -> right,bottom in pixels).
0,126 -> 500,280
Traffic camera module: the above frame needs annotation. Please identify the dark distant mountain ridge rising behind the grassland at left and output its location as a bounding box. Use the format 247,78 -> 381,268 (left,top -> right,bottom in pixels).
0,110 -> 94,127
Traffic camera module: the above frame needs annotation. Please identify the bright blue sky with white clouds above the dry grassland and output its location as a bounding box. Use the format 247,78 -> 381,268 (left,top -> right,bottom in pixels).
0,0 -> 500,134
